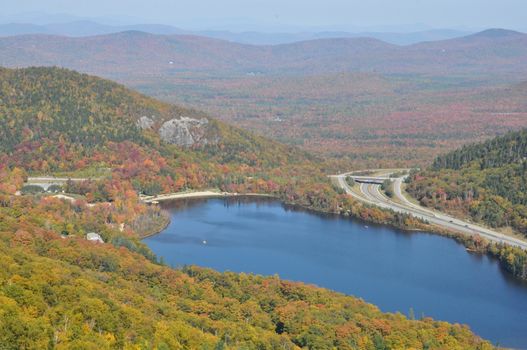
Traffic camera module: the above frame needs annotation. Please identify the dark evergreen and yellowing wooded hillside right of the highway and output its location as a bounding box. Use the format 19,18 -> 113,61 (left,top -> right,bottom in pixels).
408,129 -> 527,236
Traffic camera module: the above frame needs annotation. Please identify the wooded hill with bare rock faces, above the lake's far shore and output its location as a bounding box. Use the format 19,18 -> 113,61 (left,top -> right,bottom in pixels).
0,68 -> 313,172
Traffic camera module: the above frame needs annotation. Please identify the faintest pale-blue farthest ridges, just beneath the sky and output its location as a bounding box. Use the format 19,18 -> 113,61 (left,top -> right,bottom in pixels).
0,20 -> 470,45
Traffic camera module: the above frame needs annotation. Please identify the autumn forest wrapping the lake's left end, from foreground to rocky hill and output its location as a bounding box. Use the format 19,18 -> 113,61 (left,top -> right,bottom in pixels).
0,68 -> 500,349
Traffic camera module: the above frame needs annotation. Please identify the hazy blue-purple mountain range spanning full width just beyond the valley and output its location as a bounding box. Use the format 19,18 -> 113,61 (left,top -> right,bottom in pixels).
0,30 -> 527,78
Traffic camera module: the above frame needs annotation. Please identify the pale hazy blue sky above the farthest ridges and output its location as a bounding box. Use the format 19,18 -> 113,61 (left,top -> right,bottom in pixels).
1,0 -> 527,30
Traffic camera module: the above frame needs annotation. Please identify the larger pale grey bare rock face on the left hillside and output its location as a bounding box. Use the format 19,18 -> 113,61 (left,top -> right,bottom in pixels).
159,117 -> 209,147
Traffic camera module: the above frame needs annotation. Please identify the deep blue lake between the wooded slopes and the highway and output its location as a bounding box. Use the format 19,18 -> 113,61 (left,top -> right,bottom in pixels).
144,198 -> 527,349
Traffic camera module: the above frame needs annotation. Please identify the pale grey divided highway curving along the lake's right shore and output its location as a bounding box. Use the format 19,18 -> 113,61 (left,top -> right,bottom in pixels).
333,174 -> 527,249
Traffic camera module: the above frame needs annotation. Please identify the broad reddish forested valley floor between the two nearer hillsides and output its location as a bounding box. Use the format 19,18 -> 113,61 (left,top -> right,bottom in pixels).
138,73 -> 527,166
